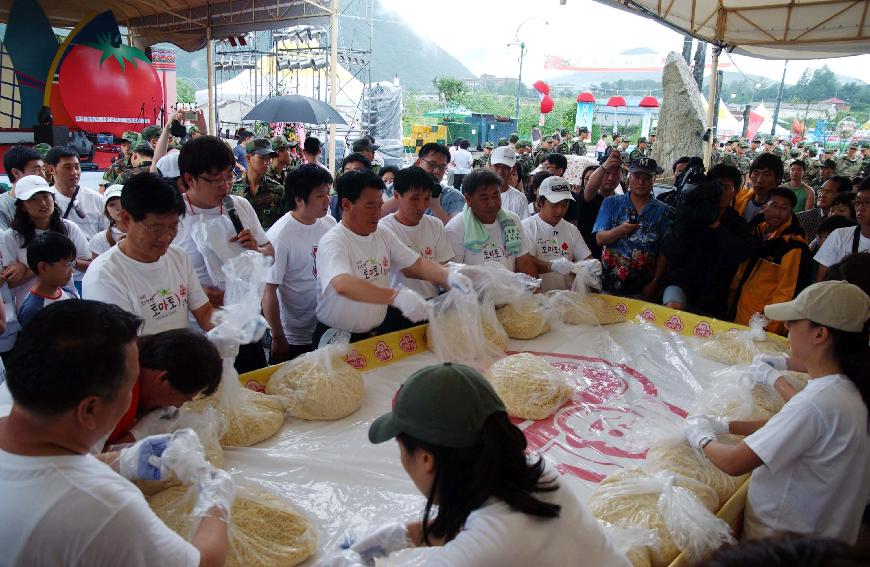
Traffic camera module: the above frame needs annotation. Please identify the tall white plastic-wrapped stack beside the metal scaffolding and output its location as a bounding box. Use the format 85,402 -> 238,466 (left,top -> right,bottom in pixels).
364,82 -> 404,166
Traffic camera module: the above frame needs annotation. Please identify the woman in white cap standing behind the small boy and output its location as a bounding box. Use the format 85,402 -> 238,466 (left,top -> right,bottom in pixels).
0,175 -> 91,304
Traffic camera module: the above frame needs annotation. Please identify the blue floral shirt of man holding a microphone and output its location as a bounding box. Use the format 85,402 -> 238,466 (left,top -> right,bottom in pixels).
592,194 -> 672,295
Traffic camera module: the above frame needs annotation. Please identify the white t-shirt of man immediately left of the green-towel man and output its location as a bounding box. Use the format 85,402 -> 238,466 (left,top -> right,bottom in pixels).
378,213 -> 453,298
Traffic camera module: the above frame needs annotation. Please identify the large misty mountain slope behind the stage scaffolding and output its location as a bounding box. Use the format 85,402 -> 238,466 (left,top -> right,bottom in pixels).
164,0 -> 475,90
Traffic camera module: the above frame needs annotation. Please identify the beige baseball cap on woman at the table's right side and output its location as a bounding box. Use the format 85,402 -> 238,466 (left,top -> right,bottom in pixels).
764,281 -> 870,333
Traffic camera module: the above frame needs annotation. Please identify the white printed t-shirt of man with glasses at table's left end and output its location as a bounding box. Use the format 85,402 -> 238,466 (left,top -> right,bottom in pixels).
82,246 -> 208,335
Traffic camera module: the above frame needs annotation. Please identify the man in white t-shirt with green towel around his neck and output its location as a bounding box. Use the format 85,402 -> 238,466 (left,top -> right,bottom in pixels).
445,169 -> 538,278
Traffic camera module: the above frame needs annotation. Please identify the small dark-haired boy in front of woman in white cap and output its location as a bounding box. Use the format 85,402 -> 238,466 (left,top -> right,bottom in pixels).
18,232 -> 79,327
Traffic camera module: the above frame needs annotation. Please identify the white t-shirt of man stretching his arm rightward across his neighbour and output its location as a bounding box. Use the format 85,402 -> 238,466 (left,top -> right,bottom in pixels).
316,222 -> 420,333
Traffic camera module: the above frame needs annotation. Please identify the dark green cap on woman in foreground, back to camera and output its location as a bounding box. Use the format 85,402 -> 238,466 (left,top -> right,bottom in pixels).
369,362 -> 507,449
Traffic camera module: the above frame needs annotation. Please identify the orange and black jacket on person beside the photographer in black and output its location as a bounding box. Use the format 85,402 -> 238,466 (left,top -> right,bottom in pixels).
729,216 -> 812,334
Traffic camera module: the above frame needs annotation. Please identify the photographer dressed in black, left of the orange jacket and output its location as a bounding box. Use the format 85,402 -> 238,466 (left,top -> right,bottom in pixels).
662,164 -> 755,319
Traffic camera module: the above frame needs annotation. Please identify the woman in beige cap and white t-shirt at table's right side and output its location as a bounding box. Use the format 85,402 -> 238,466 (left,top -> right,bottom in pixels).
686,281 -> 870,544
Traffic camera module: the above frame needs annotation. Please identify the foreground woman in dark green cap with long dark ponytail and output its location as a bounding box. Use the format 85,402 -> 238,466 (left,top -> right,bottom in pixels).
353,363 -> 629,567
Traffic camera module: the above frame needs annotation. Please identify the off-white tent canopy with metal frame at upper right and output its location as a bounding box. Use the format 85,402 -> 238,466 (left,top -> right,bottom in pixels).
598,0 -> 870,59
